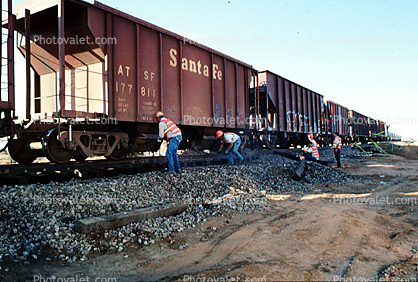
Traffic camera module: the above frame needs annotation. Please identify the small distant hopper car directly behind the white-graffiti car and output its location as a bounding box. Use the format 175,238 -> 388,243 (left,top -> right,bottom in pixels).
324,100 -> 349,137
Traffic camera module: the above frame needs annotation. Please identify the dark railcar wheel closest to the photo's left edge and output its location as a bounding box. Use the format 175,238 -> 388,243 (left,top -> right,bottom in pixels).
7,136 -> 42,164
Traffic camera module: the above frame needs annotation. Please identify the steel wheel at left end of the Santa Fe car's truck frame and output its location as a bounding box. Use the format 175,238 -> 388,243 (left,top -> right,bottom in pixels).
42,127 -> 78,164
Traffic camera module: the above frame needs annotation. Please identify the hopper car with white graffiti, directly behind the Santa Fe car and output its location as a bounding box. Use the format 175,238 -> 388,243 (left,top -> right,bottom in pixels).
255,71 -> 323,148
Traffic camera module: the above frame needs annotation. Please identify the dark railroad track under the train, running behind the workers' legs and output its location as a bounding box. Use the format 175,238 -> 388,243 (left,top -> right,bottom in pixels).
0,152 -> 259,185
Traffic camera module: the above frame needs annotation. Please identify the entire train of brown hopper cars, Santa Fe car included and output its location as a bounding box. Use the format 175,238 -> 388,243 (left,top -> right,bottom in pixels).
0,0 -> 398,164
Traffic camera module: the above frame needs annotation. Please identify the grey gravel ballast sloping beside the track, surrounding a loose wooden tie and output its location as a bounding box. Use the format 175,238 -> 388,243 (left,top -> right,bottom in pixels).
0,154 -> 357,264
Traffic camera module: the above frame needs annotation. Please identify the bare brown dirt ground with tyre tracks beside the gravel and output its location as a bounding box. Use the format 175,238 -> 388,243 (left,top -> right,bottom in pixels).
0,151 -> 418,281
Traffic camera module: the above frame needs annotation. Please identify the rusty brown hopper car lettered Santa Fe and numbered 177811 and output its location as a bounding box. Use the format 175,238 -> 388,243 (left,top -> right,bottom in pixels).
11,0 -> 255,163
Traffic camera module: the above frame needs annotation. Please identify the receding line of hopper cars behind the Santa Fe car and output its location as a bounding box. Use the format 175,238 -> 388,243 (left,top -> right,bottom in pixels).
255,71 -> 400,147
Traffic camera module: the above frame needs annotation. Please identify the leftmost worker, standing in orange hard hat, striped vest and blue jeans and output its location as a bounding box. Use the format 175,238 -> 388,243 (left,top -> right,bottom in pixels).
155,111 -> 182,172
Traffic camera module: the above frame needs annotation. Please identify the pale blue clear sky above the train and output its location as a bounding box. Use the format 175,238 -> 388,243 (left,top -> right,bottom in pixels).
14,0 -> 418,139
